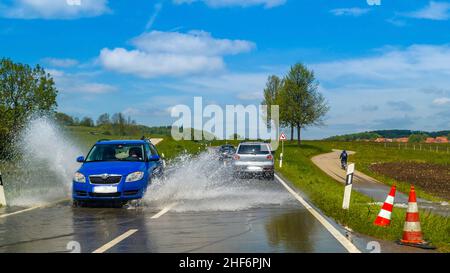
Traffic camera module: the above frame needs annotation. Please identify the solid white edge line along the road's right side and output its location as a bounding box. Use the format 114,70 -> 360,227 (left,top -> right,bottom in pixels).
275,174 -> 361,253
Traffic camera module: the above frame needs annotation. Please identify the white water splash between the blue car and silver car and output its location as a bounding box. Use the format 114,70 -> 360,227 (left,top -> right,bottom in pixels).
145,151 -> 292,212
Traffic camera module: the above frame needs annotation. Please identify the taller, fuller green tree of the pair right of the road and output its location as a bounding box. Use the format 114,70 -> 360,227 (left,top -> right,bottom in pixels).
280,63 -> 329,145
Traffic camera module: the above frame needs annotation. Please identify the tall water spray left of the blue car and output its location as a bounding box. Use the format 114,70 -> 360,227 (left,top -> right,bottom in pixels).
5,117 -> 81,206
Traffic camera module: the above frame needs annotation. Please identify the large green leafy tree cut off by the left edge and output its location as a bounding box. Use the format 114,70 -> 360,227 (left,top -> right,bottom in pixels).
0,59 -> 58,156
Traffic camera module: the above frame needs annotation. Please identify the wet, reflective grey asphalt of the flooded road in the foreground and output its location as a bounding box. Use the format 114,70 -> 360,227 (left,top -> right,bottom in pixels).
0,176 -> 354,253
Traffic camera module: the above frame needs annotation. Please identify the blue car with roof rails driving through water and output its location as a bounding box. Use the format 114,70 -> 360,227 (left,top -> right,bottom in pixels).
72,140 -> 164,206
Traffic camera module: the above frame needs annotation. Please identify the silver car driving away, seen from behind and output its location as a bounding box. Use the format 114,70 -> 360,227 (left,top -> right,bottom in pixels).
233,142 -> 274,178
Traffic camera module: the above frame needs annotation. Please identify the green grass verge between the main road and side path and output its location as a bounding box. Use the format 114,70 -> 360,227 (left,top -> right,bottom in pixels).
277,142 -> 450,252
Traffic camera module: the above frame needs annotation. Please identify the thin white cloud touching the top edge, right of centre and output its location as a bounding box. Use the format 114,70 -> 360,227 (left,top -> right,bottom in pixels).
173,0 -> 286,8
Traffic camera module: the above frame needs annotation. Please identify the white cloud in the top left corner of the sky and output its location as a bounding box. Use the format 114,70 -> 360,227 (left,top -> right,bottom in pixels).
0,0 -> 110,19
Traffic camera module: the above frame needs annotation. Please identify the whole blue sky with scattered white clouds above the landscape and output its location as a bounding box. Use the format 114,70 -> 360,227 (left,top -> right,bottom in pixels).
0,0 -> 450,138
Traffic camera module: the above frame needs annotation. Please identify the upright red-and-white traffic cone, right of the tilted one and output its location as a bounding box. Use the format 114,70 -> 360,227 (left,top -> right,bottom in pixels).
398,186 -> 435,249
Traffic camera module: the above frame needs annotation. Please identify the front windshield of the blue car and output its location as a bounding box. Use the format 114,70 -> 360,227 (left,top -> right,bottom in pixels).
86,144 -> 144,162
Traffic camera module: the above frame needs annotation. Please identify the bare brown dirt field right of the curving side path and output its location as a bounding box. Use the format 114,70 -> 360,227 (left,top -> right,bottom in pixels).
370,162 -> 450,199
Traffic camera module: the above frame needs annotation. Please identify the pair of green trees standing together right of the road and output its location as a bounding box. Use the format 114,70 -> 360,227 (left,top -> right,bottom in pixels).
262,63 -> 330,145
